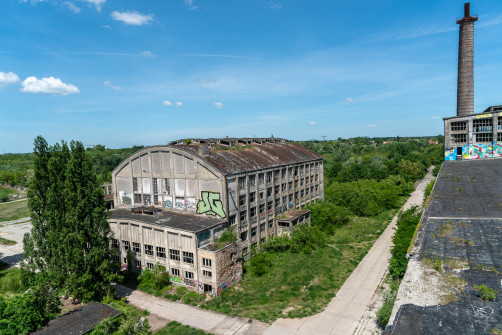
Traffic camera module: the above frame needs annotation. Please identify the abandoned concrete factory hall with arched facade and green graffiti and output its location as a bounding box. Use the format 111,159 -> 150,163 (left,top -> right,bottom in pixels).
109,138 -> 324,294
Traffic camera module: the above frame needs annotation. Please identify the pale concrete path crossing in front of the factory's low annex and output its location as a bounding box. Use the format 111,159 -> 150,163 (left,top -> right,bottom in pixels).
117,285 -> 269,335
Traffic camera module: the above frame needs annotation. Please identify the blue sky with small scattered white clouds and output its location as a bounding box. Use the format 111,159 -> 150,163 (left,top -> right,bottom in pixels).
0,0 -> 502,154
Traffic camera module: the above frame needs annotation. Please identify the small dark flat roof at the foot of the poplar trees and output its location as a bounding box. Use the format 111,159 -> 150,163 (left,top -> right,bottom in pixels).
33,301 -> 122,335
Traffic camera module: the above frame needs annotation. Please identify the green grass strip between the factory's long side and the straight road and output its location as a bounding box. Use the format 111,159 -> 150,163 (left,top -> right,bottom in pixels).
202,209 -> 397,322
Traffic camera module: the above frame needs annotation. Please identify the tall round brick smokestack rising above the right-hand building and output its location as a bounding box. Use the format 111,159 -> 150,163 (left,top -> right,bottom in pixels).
457,3 -> 478,116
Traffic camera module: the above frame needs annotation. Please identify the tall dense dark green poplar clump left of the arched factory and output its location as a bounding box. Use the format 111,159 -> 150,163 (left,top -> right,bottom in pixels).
21,136 -> 113,301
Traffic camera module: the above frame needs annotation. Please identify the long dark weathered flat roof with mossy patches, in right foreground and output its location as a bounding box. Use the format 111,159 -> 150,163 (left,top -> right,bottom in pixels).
390,159 -> 502,335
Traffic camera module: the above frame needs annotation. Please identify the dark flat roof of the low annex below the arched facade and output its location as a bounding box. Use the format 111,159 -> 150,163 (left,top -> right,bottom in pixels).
110,208 -> 226,233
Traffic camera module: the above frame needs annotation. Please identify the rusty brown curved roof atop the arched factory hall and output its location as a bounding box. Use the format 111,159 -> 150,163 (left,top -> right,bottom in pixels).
176,139 -> 322,175
